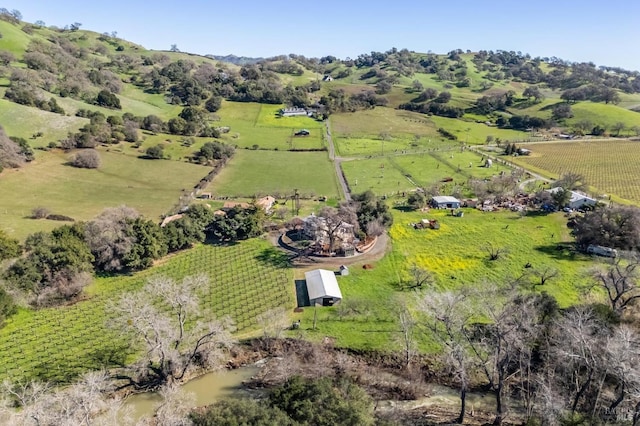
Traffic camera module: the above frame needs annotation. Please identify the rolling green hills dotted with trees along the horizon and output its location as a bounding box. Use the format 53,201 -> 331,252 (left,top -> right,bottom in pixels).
0,9 -> 640,147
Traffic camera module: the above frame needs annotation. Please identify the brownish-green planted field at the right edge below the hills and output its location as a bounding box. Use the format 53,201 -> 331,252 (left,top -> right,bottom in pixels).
512,141 -> 640,203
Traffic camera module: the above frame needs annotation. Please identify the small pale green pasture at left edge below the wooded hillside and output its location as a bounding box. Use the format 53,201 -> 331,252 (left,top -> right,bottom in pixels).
0,98 -> 89,147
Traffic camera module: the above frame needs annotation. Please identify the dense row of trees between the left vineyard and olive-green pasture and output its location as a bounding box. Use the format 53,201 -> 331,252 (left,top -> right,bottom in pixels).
0,205 -> 264,306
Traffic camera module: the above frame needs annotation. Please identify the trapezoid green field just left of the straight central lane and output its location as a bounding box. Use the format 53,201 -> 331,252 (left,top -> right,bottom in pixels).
209,149 -> 338,198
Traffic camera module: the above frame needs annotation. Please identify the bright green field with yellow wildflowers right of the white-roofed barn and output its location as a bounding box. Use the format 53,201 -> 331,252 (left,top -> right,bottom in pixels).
294,209 -> 593,351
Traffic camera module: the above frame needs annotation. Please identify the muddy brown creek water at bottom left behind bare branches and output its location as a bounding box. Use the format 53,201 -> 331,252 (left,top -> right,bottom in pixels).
125,366 -> 259,421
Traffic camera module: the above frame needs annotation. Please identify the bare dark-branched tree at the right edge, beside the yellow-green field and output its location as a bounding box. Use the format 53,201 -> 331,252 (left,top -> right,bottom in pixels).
592,259 -> 640,316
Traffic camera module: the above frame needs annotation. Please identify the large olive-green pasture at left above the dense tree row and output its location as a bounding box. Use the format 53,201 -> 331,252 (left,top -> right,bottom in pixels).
0,151 -> 210,238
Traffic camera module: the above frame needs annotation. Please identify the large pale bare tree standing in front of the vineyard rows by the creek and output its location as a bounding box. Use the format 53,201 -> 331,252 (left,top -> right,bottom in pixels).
113,275 -> 234,389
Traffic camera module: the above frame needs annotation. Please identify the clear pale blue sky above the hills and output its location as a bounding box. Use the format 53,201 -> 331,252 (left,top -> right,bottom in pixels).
8,0 -> 640,70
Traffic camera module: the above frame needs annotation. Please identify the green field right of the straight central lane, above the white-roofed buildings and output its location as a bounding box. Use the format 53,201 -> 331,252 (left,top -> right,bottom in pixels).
342,149 -> 511,195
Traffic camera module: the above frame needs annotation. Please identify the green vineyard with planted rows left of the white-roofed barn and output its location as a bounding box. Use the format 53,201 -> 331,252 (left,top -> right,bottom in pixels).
0,239 -> 294,382
